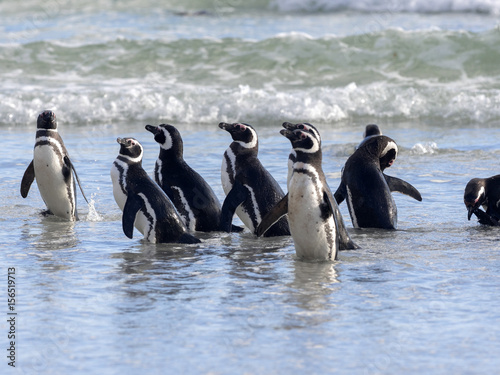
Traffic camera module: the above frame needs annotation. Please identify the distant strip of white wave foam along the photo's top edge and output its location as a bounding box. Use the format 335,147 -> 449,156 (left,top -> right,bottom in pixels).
0,0 -> 500,16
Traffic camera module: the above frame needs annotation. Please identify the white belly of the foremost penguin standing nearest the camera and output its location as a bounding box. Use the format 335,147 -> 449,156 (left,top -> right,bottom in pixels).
288,173 -> 336,259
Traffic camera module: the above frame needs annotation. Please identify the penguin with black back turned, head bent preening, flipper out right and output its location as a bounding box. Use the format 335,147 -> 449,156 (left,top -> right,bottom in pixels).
335,135 -> 422,229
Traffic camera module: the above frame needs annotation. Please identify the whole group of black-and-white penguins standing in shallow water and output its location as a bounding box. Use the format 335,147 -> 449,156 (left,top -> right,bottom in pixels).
21,110 -> 500,260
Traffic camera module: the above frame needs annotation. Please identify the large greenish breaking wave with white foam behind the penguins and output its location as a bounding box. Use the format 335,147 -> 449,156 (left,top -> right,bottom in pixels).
0,29 -> 500,126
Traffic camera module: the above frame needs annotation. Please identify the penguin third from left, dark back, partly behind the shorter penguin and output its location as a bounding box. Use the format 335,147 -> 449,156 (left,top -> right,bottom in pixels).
146,124 -> 243,232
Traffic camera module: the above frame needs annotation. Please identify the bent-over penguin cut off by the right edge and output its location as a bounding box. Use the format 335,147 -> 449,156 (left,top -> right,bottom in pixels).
464,175 -> 500,226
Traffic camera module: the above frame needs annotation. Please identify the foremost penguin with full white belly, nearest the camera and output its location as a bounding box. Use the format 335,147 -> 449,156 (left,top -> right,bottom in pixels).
257,123 -> 340,260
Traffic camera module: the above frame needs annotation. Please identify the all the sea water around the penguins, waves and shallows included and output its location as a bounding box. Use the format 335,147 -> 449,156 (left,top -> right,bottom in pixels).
0,0 -> 500,374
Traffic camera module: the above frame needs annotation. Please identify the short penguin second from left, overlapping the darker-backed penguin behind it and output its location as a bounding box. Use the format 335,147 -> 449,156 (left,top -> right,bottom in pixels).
111,138 -> 200,244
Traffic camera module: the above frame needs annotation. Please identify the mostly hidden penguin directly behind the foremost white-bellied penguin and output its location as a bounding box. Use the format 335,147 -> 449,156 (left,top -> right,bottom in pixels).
283,122 -> 359,250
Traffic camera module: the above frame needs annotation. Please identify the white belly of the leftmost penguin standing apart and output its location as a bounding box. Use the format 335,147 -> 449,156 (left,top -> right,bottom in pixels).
33,145 -> 76,220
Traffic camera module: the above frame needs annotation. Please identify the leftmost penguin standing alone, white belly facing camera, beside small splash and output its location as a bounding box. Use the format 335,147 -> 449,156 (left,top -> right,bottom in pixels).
21,111 -> 87,220
